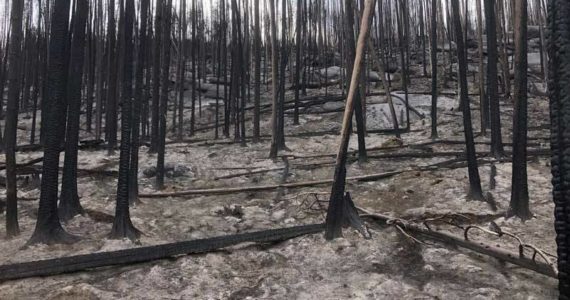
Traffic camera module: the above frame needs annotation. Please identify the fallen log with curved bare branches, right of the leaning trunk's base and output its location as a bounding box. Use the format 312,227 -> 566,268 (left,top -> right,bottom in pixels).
358,208 -> 557,278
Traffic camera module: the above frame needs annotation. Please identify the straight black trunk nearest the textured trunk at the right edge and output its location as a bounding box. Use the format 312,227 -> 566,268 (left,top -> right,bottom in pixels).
509,0 -> 532,220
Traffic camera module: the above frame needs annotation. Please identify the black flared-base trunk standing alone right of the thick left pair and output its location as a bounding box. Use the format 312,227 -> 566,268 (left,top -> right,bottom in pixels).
109,0 -> 140,241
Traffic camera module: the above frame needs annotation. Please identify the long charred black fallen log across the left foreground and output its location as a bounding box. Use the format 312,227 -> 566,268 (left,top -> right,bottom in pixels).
0,224 -> 324,282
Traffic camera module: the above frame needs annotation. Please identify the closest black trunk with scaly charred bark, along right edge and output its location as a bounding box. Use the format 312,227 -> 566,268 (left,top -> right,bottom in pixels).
547,0 -> 570,299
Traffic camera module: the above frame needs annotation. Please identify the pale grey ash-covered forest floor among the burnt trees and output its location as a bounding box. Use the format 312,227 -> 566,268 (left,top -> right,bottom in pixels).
0,55 -> 557,299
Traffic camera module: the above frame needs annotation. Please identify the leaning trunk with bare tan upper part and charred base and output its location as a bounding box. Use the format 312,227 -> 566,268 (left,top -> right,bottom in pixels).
325,0 -> 376,240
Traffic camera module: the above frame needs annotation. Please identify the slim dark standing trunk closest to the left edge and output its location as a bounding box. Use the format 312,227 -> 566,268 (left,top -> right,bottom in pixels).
4,0 -> 24,237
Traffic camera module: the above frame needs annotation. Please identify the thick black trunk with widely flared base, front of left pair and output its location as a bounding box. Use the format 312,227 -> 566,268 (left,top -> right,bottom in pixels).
28,0 -> 79,244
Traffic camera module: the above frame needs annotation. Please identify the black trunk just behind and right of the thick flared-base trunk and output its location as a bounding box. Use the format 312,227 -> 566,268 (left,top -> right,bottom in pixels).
59,0 -> 89,222
